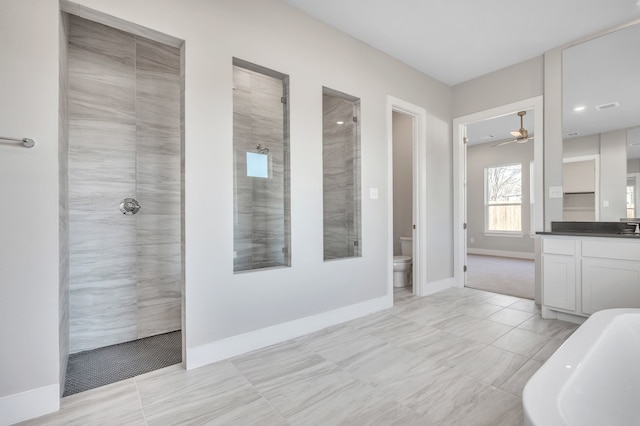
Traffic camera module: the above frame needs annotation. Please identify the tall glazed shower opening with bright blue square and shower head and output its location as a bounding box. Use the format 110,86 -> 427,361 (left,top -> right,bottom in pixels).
233,58 -> 291,272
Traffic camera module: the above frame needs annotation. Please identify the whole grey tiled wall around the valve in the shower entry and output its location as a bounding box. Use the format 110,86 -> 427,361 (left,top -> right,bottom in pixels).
67,15 -> 182,353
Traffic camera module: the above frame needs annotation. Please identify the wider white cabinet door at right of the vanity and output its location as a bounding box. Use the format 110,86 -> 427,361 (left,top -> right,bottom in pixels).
582,258 -> 640,314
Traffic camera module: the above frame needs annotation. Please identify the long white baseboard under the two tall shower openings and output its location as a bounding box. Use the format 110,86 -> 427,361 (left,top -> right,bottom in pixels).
186,294 -> 393,370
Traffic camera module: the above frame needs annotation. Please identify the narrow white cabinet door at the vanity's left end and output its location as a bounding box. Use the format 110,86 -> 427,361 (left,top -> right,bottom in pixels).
542,254 -> 576,311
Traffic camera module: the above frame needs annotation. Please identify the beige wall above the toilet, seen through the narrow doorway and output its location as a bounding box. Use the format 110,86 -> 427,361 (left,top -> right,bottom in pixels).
393,111 -> 413,256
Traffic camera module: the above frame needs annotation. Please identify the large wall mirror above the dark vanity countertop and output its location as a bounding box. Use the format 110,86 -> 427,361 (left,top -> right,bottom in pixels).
562,24 -> 640,222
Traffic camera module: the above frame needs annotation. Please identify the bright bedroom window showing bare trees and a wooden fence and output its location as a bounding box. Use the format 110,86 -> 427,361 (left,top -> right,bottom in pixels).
485,164 -> 522,232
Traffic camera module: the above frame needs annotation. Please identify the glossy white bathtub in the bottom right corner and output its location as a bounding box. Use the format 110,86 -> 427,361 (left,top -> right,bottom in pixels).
522,309 -> 640,426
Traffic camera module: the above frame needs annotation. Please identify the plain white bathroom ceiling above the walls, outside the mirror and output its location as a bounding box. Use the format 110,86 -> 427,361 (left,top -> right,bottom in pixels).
282,0 -> 640,86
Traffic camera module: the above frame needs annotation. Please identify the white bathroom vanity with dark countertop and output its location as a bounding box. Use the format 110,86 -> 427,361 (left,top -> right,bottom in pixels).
538,222 -> 640,323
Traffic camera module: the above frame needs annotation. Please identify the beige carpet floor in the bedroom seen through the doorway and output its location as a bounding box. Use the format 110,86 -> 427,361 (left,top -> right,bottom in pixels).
466,254 -> 535,299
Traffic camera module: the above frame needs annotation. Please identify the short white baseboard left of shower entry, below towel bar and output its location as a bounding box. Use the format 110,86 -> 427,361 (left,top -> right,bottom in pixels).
0,384 -> 60,426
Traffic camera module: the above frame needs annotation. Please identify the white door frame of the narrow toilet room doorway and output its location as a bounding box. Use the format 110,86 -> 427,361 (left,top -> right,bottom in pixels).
387,96 -> 427,296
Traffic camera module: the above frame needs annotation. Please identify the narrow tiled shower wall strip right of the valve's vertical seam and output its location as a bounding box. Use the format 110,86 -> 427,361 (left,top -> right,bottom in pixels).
136,37 -> 182,338
